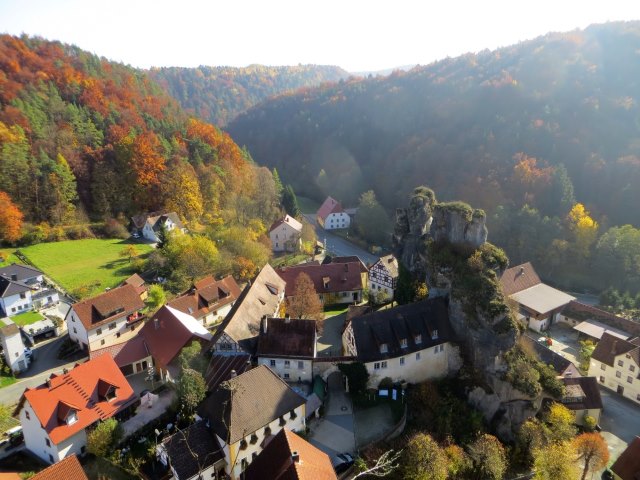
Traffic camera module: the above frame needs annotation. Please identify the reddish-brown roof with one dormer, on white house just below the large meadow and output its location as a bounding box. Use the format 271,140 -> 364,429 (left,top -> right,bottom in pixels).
71,285 -> 144,331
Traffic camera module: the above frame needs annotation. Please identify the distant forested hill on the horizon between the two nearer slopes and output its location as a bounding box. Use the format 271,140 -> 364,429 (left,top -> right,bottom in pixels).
150,65 -> 349,125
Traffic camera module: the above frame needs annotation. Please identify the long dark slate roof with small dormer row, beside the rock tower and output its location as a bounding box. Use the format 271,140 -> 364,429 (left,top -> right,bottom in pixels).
351,298 -> 455,362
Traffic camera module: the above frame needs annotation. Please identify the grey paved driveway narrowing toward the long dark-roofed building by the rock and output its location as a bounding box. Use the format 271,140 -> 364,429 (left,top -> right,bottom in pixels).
309,372 -> 356,458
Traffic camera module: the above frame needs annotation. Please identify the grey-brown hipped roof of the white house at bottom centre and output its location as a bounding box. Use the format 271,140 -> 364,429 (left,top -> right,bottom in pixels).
198,365 -> 305,444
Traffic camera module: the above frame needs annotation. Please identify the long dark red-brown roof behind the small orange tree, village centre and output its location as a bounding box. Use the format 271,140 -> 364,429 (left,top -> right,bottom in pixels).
276,262 -> 363,297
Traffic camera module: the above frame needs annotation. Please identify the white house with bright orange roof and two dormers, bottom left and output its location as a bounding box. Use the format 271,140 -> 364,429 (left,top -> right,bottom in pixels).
15,355 -> 137,463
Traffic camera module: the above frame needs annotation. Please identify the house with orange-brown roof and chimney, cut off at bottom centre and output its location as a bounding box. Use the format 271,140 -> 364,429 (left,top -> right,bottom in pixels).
243,428 -> 338,480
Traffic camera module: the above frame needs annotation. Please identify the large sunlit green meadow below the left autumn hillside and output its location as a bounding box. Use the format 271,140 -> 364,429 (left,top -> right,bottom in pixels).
20,238 -> 152,297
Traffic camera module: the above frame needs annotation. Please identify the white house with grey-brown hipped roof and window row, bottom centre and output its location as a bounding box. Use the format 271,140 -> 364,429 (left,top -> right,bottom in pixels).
198,365 -> 305,480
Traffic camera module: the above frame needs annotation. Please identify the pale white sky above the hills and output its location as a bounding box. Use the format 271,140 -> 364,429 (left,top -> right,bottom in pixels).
0,0 -> 640,72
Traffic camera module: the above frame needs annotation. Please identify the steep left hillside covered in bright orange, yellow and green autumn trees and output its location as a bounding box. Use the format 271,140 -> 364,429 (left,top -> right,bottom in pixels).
0,35 -> 279,278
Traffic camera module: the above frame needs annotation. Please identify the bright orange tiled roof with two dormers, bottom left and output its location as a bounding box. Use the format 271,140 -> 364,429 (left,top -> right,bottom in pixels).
17,355 -> 136,445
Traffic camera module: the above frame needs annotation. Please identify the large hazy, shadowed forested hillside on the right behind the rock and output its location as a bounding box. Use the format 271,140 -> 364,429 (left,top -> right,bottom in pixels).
228,22 -> 640,296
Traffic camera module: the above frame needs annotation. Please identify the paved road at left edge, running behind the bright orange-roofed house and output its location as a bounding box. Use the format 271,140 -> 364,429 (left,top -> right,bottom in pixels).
0,334 -> 83,405
